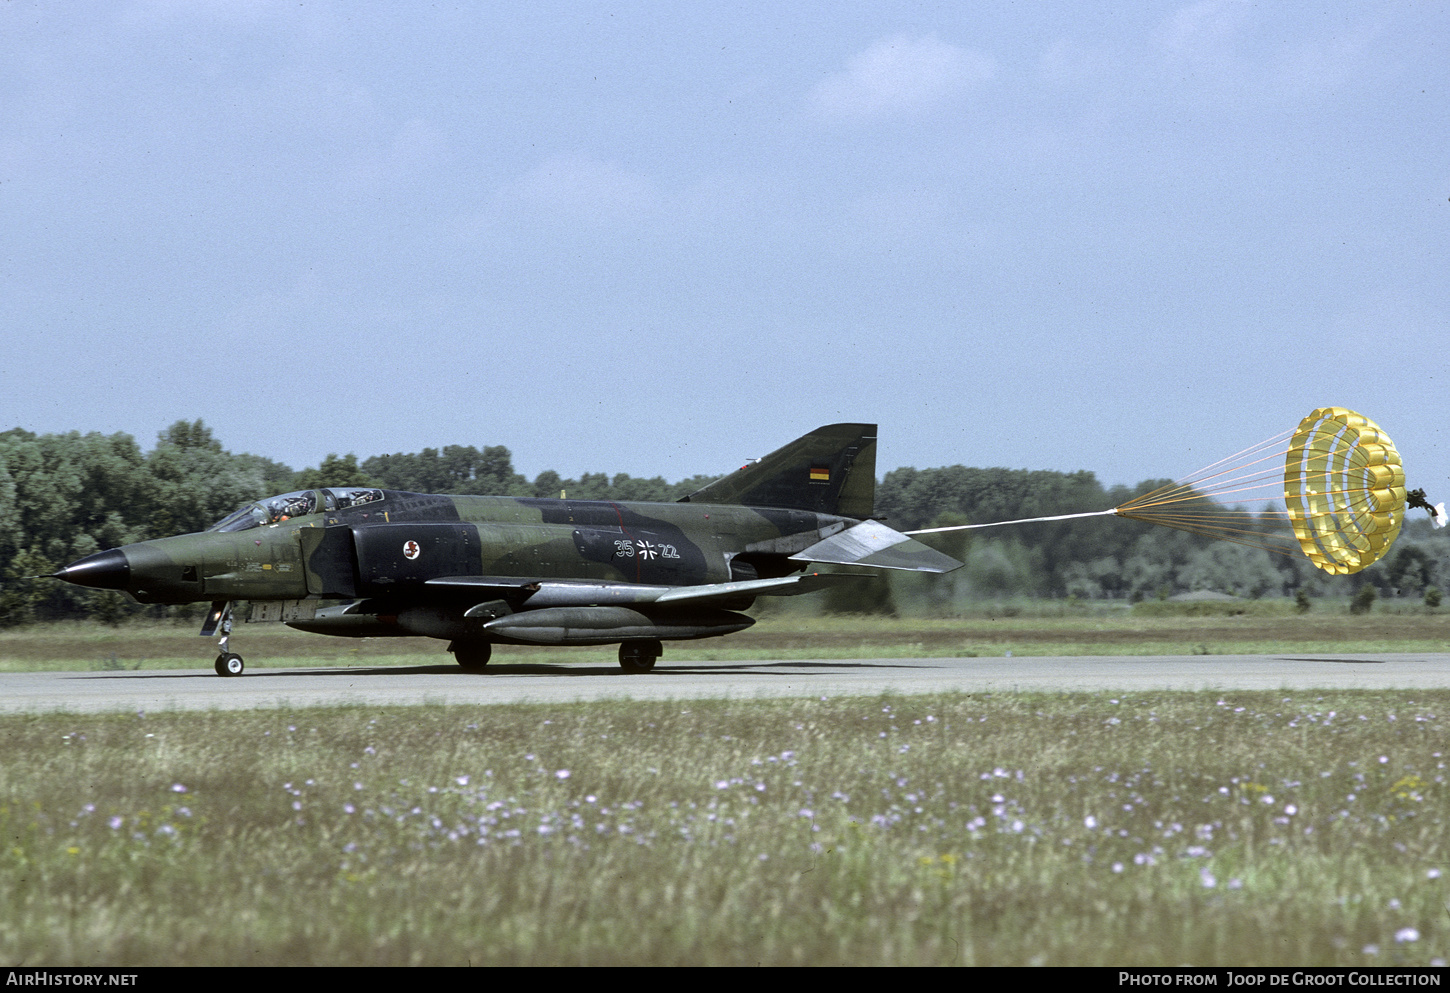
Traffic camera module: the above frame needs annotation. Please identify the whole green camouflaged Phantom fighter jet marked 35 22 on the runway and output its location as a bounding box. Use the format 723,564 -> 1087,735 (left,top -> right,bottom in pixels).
54,425 -> 961,676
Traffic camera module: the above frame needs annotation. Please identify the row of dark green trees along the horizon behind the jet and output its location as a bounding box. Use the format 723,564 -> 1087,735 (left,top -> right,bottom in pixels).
0,420 -> 1450,625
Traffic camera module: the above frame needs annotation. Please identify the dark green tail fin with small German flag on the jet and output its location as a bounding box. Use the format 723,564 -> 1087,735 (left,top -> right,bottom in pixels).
682,425 -> 876,520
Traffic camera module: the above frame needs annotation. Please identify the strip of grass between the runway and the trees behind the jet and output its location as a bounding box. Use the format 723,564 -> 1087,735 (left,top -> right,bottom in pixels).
0,602 -> 1450,671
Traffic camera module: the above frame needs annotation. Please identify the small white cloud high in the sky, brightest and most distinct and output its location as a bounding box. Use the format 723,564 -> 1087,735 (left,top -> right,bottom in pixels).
811,35 -> 996,117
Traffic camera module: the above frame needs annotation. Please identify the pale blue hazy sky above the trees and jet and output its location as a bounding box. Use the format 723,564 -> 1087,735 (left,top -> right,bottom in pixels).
0,0 -> 1450,500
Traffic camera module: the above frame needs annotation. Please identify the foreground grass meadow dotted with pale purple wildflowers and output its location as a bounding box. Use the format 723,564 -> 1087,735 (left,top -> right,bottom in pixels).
0,691 -> 1450,965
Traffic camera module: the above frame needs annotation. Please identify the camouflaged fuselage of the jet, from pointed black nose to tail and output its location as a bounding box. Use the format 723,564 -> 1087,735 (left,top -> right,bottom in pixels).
61,490 -> 856,603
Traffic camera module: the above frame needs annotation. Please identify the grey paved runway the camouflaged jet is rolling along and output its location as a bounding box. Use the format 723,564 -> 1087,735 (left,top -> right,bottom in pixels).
0,652 -> 1450,713
